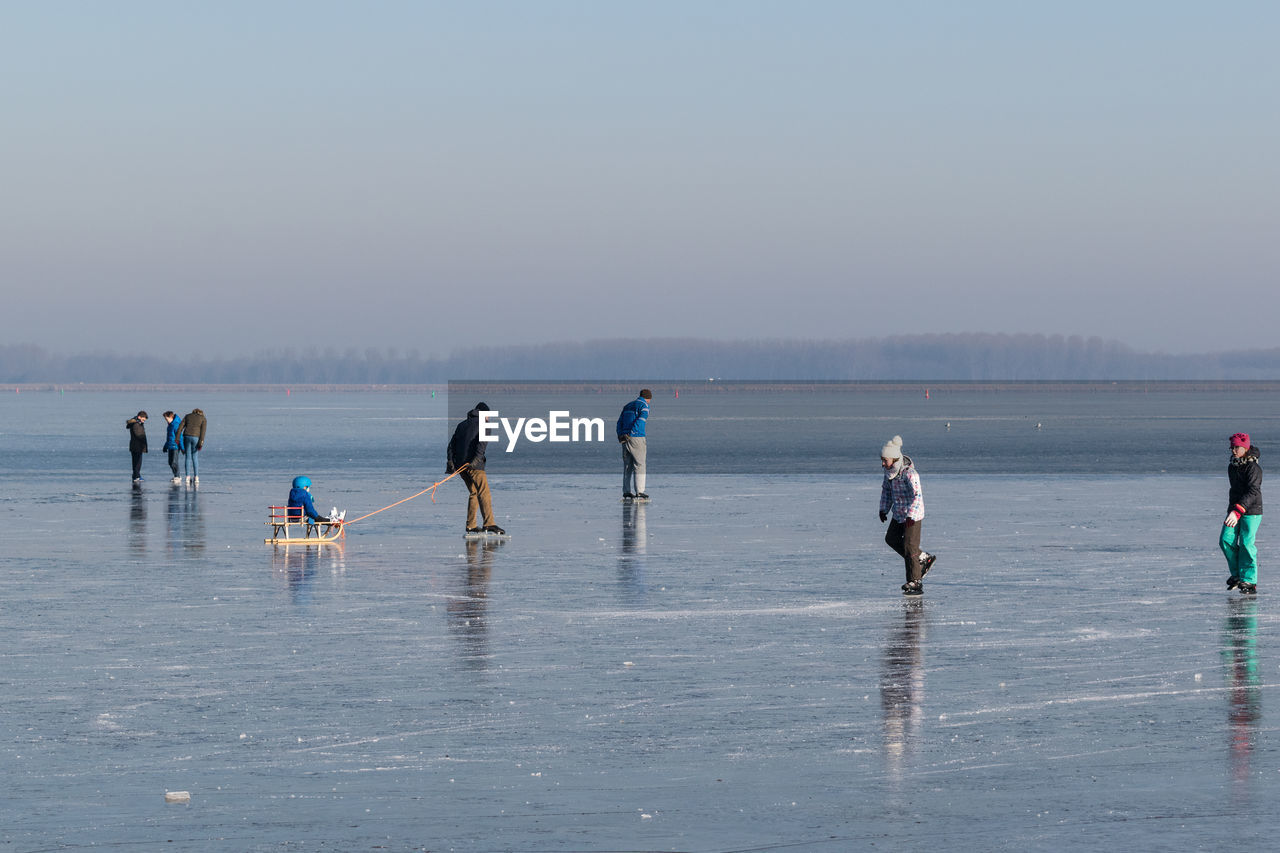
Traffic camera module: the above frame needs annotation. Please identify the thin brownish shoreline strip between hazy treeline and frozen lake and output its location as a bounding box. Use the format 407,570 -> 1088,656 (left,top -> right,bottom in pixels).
0,379 -> 1280,394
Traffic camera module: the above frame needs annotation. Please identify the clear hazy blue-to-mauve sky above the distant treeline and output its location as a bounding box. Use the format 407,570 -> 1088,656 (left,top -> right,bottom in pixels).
0,0 -> 1280,357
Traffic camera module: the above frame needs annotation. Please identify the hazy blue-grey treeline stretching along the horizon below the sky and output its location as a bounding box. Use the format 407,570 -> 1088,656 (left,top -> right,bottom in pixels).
0,334 -> 1280,386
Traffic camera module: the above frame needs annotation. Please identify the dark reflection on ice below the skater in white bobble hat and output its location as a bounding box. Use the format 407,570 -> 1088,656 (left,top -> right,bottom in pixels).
879,601 -> 924,781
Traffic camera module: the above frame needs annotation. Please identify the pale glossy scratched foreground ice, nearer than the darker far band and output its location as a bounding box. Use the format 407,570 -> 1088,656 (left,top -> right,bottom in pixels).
0,389 -> 1280,853
